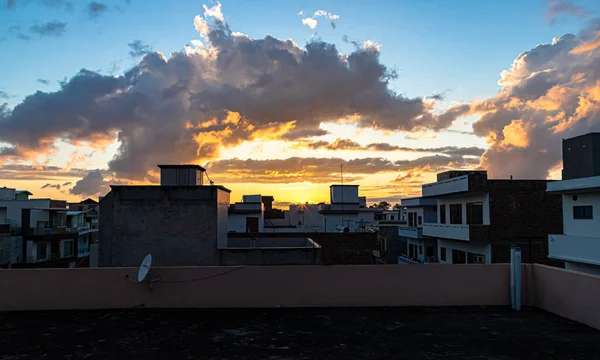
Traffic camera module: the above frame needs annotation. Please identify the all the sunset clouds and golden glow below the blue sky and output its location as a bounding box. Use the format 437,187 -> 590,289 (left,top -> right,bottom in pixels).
0,1 -> 600,203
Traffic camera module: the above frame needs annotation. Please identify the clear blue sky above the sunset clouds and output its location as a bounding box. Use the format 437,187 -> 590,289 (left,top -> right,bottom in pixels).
0,0 -> 600,105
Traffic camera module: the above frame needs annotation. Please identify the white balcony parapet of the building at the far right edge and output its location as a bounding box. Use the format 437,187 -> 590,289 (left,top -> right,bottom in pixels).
548,235 -> 600,265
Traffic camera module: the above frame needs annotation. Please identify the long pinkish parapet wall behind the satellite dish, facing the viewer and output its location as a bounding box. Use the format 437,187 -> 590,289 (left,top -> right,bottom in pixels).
0,264 -> 510,311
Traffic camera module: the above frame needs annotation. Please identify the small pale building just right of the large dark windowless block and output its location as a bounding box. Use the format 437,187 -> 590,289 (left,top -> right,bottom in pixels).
227,195 -> 265,233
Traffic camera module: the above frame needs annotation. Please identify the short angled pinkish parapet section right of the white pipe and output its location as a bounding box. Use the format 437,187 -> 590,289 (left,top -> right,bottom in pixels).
531,264 -> 600,329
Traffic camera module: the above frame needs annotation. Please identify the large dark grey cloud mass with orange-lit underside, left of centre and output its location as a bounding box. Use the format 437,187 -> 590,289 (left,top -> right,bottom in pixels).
0,7 -> 468,183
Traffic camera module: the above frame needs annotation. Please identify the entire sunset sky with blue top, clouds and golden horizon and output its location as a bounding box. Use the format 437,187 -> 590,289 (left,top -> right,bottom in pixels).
0,0 -> 600,205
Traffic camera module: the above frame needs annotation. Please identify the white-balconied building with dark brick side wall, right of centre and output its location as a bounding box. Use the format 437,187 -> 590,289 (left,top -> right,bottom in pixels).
417,171 -> 562,264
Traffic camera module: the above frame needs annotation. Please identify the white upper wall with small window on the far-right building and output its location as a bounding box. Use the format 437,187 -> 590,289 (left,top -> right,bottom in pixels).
562,192 -> 600,237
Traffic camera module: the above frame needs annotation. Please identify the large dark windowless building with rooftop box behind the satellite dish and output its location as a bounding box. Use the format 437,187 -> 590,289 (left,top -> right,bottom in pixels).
99,165 -> 230,266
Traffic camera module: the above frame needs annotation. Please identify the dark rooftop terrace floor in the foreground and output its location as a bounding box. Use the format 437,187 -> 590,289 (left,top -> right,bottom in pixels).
0,307 -> 600,360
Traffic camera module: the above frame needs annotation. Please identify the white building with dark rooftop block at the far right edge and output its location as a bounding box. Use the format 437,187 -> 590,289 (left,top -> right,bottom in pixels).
547,133 -> 600,275
